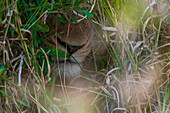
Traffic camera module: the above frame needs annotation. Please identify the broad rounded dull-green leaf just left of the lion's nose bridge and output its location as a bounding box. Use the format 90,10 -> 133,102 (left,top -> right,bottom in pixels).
35,20 -> 50,32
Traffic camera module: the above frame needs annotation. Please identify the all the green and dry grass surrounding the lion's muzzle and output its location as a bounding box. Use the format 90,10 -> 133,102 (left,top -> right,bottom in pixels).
0,0 -> 170,113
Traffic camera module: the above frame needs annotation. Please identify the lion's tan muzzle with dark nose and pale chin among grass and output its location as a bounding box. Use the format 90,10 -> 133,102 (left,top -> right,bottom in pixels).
50,20 -> 94,77
